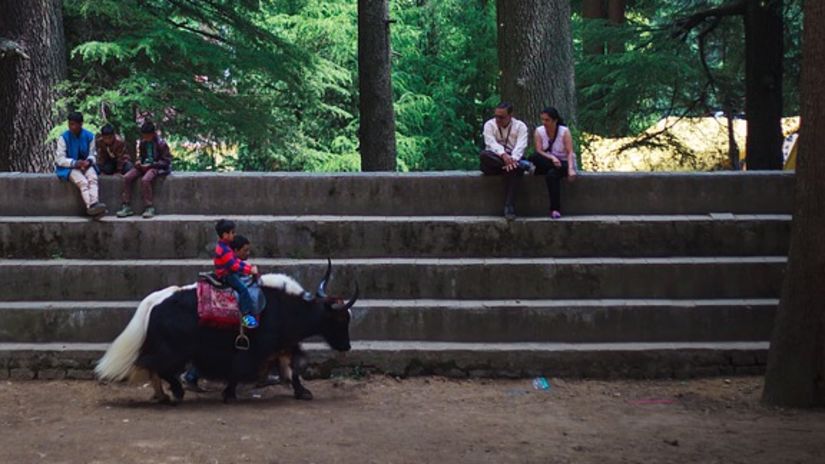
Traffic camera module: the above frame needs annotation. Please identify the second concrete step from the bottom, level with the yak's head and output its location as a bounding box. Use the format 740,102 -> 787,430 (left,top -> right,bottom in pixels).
0,299 -> 778,343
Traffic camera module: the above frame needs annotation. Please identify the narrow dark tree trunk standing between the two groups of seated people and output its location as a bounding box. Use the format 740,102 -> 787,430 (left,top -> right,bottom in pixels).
358,0 -> 396,171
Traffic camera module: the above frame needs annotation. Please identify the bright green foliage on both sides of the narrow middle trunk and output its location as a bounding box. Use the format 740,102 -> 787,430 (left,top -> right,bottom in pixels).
61,0 -> 497,171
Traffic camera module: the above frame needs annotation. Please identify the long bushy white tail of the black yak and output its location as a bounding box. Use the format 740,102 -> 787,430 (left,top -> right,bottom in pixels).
95,286 -> 180,381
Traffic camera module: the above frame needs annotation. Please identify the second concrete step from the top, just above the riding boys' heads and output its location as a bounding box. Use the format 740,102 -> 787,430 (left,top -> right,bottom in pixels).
0,214 -> 791,259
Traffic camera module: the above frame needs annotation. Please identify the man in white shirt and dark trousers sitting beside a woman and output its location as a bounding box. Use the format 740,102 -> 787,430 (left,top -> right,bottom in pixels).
479,102 -> 535,220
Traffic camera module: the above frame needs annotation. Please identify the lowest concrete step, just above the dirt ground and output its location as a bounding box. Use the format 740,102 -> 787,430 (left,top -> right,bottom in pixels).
0,341 -> 768,380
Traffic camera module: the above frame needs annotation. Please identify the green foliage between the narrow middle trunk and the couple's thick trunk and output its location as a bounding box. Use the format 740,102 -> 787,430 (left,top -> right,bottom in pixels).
392,0 -> 498,170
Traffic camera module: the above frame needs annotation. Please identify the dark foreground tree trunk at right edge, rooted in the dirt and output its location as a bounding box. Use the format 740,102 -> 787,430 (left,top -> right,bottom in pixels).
762,1 -> 825,407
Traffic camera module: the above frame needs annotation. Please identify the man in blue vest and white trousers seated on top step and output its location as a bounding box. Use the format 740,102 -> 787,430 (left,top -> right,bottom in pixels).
55,112 -> 106,217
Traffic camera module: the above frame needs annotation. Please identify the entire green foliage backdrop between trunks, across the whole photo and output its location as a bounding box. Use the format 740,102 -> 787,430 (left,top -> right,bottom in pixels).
61,0 -> 802,171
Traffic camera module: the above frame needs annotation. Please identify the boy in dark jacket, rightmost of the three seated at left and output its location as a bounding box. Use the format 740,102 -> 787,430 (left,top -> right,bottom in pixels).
117,122 -> 172,219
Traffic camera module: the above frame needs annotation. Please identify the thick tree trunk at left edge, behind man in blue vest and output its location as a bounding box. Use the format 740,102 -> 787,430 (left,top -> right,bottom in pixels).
0,0 -> 66,172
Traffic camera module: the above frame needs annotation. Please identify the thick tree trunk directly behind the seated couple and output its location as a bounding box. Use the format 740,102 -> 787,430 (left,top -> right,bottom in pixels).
496,0 -> 576,129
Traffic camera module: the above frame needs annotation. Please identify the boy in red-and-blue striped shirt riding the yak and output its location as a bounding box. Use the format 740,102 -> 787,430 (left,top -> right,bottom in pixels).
213,219 -> 258,329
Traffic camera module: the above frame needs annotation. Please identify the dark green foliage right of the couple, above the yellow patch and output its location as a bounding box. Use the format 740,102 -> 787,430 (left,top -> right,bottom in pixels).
573,0 -> 802,145
